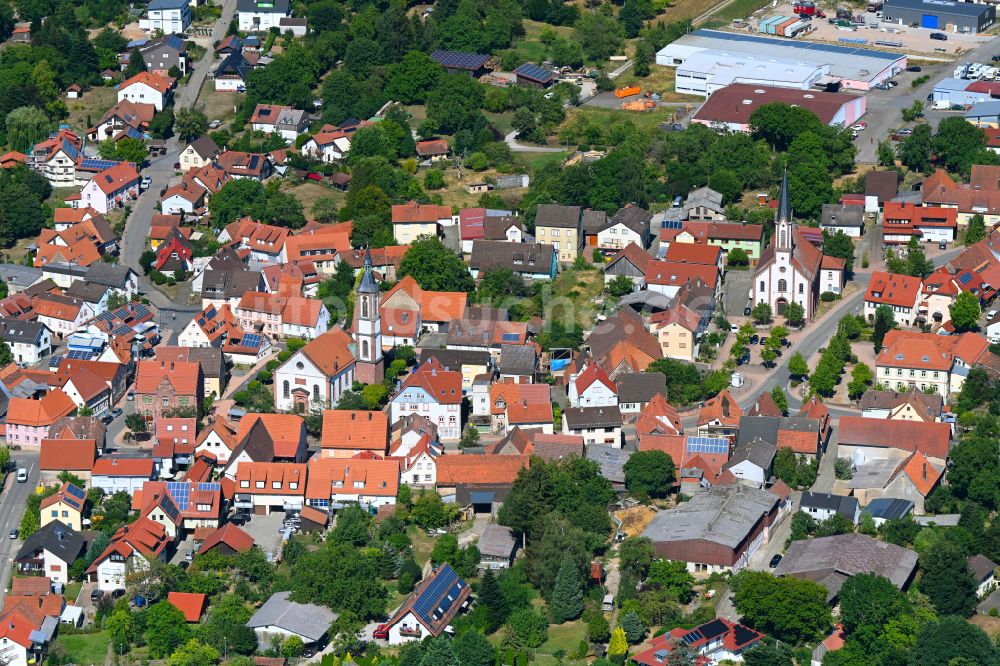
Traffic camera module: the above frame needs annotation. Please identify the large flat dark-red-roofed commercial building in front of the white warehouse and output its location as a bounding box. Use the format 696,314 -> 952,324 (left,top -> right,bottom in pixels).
691,83 -> 868,132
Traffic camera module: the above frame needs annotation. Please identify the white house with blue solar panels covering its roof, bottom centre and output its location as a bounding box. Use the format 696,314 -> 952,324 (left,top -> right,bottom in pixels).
386,563 -> 472,645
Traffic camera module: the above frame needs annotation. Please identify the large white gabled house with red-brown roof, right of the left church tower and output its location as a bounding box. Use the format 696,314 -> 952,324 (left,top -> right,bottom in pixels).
389,358 -> 462,442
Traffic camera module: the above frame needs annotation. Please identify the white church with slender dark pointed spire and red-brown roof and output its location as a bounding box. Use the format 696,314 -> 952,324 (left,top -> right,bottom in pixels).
751,171 -> 823,319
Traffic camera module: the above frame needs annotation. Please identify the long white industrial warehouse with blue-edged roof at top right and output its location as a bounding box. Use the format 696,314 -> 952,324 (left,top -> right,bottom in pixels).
656,30 -> 906,97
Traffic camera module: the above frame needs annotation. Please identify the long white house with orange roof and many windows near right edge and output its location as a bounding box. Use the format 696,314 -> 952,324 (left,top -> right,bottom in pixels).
875,330 -> 993,400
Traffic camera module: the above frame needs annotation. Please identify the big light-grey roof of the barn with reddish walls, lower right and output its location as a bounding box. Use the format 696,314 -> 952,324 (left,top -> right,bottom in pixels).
642,483 -> 781,548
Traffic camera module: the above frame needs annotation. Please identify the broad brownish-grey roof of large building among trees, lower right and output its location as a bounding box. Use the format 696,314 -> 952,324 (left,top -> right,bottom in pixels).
774,533 -> 917,600
